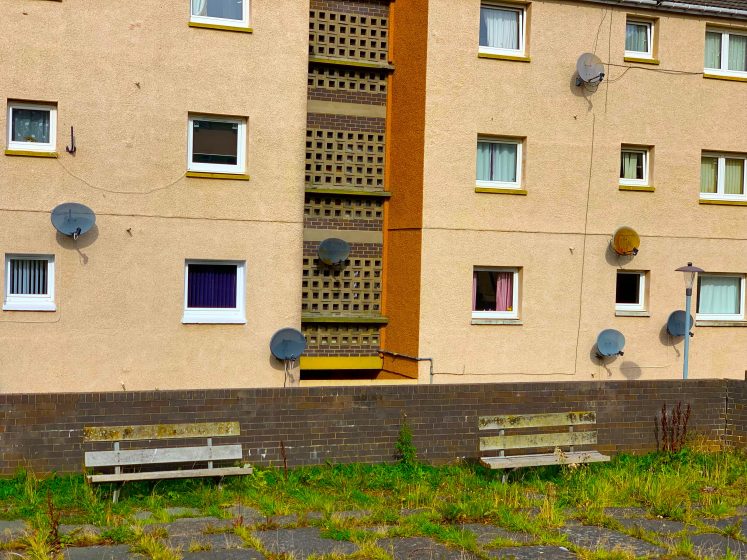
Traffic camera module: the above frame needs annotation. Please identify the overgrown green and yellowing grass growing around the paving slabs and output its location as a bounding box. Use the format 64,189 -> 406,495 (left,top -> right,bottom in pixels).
0,448 -> 747,560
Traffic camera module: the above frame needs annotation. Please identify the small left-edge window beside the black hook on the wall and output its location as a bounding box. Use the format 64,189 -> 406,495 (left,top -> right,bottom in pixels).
8,102 -> 57,152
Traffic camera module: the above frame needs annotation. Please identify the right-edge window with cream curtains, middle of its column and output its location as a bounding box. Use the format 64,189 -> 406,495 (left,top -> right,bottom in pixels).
700,153 -> 747,200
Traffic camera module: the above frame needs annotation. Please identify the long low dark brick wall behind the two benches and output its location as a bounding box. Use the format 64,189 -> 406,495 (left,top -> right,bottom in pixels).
0,379 -> 747,475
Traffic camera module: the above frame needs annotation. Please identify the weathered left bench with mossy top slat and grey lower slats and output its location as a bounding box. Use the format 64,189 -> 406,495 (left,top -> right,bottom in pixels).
83,422 -> 252,502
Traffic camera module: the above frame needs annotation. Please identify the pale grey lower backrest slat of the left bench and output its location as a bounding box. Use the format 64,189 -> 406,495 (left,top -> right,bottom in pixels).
85,445 -> 241,467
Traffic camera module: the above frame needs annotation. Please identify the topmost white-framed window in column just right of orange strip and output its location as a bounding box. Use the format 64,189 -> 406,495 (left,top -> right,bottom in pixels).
480,4 -> 526,56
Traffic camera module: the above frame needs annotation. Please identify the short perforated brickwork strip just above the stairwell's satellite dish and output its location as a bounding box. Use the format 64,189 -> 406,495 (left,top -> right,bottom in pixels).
303,193 -> 384,231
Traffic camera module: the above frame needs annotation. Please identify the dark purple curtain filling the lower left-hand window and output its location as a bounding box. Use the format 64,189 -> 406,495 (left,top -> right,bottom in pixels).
187,264 -> 236,309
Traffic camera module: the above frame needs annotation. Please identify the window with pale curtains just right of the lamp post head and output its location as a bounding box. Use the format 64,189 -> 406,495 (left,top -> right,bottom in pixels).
696,274 -> 744,321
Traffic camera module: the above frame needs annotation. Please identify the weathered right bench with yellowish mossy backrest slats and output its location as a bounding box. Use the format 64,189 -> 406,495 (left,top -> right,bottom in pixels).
478,412 -> 610,482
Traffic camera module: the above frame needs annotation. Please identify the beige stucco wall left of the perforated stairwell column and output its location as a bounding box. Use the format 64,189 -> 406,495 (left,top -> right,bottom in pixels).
0,0 -> 308,392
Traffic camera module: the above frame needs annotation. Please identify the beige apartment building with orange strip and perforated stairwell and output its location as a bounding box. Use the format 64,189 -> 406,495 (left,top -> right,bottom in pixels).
0,0 -> 747,392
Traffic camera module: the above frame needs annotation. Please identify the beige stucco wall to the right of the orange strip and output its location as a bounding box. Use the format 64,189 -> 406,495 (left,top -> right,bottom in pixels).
419,0 -> 747,382
